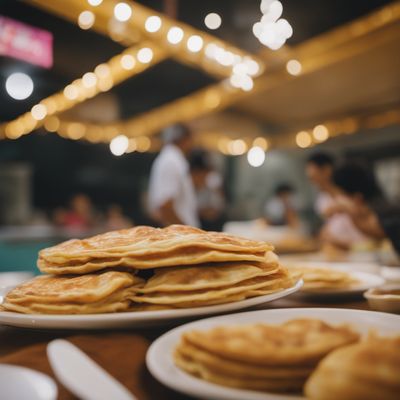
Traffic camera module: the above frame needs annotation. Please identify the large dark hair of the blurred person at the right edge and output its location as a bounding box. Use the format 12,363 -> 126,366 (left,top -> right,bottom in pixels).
333,162 -> 382,201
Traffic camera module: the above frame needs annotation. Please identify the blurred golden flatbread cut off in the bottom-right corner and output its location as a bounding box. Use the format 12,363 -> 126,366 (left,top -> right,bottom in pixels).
305,337 -> 400,400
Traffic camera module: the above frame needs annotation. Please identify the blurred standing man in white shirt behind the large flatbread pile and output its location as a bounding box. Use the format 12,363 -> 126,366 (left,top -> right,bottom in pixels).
148,125 -> 200,226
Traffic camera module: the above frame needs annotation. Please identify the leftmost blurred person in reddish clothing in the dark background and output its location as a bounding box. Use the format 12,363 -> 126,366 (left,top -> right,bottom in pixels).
54,193 -> 95,231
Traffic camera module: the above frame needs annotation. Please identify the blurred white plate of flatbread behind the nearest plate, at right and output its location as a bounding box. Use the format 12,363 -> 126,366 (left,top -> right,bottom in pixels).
288,263 -> 385,298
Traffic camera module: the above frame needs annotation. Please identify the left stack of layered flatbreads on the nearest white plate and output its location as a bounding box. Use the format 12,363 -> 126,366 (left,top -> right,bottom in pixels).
174,319 -> 359,392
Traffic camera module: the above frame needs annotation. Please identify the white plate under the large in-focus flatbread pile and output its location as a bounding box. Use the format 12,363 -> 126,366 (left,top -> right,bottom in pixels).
0,280 -> 303,329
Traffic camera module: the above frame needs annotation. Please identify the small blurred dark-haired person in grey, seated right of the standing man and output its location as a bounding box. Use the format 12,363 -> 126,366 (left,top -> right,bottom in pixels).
264,183 -> 300,228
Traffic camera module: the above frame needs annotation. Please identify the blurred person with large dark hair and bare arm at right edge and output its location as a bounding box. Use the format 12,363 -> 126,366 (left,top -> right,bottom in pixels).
330,162 -> 400,254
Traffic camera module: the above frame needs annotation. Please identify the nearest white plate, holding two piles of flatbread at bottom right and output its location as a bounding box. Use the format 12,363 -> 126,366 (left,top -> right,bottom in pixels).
146,308 -> 400,400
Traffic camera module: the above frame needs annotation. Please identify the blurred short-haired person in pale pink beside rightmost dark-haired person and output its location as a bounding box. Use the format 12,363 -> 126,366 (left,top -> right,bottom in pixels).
306,152 -> 368,250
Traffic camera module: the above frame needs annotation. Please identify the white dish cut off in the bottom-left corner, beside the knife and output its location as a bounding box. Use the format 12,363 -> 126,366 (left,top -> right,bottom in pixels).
0,364 -> 58,400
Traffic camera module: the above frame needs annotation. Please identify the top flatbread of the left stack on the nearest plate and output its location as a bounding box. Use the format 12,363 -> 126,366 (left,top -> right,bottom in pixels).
183,319 -> 359,366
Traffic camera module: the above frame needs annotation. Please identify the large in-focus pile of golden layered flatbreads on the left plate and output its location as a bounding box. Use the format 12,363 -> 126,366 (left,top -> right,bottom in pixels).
3,225 -> 294,314
